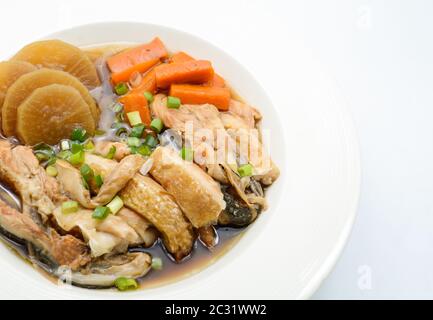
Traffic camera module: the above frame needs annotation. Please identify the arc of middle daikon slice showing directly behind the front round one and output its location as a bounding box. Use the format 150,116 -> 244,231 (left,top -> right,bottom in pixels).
2,68 -> 99,136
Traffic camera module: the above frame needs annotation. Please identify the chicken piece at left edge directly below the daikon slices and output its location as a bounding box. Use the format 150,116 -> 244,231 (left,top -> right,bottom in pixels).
0,140 -> 64,220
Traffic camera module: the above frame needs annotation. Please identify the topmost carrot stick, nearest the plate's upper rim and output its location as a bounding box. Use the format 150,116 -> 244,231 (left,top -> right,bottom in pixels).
107,38 -> 168,73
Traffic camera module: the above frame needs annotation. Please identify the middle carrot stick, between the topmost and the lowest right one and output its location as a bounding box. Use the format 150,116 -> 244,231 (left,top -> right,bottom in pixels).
155,60 -> 214,88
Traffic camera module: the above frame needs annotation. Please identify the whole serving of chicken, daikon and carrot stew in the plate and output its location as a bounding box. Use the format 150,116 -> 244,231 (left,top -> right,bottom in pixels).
0,38 -> 279,290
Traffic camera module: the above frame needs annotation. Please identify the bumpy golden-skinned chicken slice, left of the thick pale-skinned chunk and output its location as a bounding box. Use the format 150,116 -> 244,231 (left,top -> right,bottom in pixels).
120,174 -> 194,261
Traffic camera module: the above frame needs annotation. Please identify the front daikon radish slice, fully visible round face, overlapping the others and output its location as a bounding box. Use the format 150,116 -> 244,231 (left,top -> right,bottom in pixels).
17,84 -> 95,145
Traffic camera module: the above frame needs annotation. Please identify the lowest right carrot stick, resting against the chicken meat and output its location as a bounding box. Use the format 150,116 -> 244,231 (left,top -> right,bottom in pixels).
170,84 -> 231,111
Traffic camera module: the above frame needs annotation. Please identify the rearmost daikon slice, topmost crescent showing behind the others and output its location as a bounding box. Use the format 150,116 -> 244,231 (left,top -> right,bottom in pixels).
12,40 -> 99,88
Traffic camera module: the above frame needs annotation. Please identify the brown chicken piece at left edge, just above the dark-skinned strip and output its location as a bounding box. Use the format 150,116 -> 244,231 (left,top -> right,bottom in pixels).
0,200 -> 90,270
